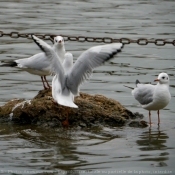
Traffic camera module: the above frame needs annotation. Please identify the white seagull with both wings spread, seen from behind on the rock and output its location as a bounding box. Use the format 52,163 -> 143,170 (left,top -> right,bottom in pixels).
32,35 -> 123,108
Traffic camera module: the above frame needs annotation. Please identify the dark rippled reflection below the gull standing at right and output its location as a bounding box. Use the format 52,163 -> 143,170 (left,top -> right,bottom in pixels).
136,127 -> 169,166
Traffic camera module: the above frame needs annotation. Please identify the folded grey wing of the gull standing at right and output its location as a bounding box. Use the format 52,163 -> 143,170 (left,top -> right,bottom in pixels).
132,84 -> 155,105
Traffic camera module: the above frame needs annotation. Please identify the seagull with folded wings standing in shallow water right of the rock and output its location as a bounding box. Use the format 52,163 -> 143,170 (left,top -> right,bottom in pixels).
132,73 -> 171,125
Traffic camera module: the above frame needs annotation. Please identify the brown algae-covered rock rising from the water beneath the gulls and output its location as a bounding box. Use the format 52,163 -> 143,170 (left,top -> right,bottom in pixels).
0,89 -> 147,127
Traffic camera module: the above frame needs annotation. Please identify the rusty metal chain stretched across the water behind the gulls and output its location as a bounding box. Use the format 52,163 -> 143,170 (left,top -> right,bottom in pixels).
0,31 -> 175,46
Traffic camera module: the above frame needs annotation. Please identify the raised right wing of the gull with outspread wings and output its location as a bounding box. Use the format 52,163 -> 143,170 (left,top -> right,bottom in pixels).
66,43 -> 123,95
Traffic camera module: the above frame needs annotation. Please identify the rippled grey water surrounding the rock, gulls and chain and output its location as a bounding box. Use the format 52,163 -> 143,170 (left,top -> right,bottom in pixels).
0,0 -> 175,175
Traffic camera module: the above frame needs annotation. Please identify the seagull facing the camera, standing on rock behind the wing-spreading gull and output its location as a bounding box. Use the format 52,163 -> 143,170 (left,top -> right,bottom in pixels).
1,36 -> 65,89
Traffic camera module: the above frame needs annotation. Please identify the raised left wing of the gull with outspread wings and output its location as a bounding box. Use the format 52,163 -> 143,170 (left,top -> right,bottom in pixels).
32,35 -> 65,84
